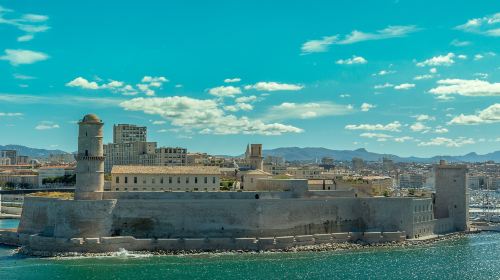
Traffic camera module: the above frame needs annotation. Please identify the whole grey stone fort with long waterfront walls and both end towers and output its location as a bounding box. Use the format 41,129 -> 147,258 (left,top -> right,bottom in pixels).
0,114 -> 468,252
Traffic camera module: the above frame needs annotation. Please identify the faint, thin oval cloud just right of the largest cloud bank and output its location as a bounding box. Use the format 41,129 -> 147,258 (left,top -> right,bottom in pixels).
265,102 -> 352,120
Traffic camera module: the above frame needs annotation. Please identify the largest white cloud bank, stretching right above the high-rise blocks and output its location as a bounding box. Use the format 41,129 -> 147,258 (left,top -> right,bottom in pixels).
120,96 -> 303,135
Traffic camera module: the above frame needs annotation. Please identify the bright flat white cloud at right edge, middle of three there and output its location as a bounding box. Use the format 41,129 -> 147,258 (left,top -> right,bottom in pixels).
429,79 -> 500,98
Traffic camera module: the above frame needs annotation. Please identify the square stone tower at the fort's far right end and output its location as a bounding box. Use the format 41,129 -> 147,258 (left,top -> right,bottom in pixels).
434,160 -> 469,231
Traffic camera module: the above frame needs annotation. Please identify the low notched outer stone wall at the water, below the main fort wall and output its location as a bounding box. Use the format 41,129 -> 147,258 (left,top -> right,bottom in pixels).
0,231 -> 405,254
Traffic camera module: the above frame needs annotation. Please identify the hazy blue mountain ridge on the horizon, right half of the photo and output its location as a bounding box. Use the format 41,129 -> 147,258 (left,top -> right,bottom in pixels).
263,147 -> 500,163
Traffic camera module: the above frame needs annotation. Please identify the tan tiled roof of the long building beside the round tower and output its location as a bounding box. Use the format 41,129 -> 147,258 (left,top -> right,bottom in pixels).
111,165 -> 220,175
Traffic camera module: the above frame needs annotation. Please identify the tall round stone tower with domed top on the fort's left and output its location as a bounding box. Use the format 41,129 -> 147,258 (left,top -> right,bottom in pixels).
75,114 -> 104,199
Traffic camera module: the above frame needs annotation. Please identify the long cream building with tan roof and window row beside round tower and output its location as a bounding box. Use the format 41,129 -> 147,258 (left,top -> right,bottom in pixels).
111,165 -> 221,191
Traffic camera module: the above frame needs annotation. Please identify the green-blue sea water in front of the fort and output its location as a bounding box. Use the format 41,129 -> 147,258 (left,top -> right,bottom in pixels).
0,220 -> 500,280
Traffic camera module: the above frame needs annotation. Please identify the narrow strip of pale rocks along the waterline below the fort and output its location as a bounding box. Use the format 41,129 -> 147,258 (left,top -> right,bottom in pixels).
16,232 -> 479,258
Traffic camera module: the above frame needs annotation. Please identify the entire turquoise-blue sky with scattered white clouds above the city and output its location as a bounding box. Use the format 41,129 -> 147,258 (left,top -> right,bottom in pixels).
0,0 -> 500,156
